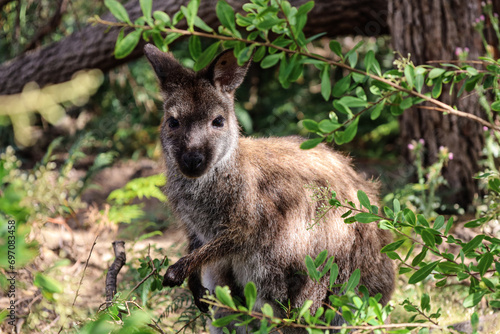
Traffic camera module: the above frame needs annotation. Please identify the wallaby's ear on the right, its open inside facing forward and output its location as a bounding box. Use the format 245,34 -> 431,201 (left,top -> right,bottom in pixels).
207,50 -> 251,92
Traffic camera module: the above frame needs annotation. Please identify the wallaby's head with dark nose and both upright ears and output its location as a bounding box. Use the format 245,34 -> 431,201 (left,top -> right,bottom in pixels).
144,44 -> 250,178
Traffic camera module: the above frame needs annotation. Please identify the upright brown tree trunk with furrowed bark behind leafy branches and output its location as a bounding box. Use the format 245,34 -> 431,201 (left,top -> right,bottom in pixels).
388,0 -> 483,207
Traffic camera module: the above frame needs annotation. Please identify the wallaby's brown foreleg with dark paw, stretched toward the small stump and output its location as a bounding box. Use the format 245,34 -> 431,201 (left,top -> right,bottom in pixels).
163,230 -> 242,287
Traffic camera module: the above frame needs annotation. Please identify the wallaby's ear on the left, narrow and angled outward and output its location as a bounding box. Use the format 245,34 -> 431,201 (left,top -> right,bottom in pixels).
144,44 -> 190,91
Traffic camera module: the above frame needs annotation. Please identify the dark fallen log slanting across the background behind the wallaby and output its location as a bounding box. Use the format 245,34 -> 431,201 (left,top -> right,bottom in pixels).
0,0 -> 388,95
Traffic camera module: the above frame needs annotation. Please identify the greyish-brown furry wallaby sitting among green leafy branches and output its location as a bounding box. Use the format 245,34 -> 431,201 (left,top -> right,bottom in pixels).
144,44 -> 394,333
